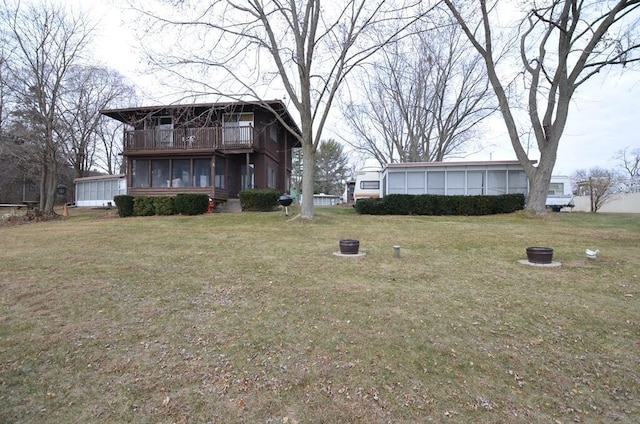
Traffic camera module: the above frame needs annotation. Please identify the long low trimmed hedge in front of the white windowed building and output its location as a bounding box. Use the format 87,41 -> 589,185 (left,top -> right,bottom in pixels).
355,193 -> 525,215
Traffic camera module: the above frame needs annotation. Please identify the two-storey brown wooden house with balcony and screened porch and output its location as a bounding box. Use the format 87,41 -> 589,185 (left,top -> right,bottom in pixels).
102,100 -> 299,202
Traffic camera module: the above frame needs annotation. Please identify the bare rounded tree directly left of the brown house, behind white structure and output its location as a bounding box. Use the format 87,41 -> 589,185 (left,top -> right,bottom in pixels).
55,66 -> 134,178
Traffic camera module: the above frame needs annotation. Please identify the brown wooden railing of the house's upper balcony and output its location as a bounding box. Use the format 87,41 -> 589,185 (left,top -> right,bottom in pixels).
124,127 -> 254,153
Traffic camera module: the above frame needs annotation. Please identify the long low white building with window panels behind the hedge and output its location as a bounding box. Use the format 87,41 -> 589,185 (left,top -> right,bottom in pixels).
382,161 -> 529,197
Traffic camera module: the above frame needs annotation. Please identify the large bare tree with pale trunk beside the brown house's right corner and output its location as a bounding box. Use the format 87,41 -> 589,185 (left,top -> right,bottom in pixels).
133,0 -> 424,218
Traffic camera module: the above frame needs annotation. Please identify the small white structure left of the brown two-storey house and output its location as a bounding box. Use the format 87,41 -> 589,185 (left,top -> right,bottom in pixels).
73,174 -> 127,207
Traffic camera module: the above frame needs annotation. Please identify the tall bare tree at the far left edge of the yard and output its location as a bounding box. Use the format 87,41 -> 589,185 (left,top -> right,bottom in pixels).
0,0 -> 92,214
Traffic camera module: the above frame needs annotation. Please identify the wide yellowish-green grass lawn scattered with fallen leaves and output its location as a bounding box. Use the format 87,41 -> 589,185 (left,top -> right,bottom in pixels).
0,207 -> 640,424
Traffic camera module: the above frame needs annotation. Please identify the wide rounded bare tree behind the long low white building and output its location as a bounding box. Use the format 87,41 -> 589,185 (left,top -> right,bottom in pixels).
344,14 -> 495,165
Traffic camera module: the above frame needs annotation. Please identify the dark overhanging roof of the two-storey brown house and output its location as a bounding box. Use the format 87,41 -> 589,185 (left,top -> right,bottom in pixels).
100,100 -> 301,134
